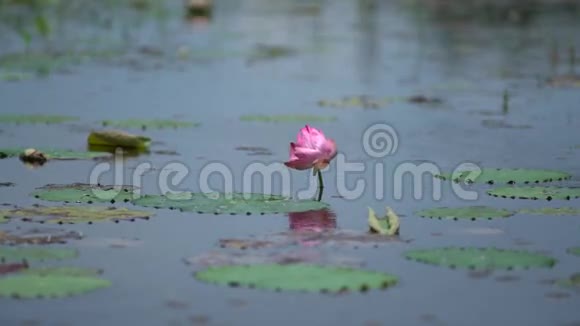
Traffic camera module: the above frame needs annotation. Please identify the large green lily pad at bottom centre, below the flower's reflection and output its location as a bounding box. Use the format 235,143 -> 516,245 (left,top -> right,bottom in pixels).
195,264 -> 398,293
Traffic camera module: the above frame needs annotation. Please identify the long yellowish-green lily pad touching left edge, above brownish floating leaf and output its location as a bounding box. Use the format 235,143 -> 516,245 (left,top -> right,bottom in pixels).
0,206 -> 152,224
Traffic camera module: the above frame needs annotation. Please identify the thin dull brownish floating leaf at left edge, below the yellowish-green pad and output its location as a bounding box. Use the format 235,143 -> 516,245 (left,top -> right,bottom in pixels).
0,229 -> 83,245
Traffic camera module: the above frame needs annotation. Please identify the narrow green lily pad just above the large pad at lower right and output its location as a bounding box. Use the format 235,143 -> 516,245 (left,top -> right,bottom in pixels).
417,206 -> 514,221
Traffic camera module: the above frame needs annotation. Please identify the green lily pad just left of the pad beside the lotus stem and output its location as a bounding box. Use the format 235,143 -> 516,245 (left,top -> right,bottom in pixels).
31,183 -> 135,204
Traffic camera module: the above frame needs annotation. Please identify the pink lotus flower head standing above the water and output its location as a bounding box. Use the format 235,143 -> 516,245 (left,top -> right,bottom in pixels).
284,125 -> 336,173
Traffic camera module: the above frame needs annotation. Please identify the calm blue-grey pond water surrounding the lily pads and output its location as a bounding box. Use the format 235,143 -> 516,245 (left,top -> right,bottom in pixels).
0,0 -> 580,325
